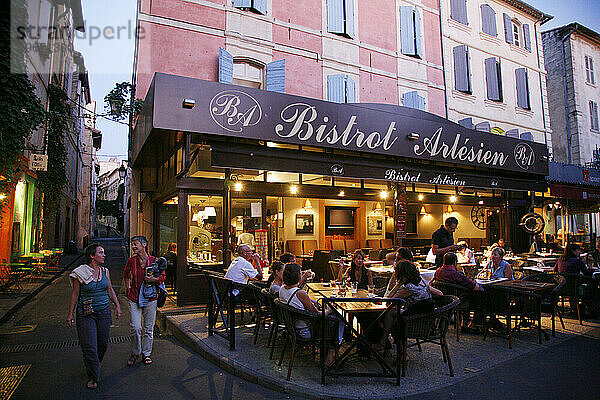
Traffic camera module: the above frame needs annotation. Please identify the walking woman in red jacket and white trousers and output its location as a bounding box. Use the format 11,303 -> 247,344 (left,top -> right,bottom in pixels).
123,236 -> 166,367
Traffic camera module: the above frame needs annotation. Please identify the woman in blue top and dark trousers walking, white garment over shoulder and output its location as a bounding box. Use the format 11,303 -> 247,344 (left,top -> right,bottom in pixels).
67,243 -> 121,389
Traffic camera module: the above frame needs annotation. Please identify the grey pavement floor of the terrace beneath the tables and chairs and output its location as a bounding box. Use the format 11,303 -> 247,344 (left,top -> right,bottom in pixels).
157,298 -> 600,399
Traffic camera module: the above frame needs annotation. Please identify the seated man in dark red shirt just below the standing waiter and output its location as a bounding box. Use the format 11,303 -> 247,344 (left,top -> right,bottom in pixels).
435,252 -> 483,333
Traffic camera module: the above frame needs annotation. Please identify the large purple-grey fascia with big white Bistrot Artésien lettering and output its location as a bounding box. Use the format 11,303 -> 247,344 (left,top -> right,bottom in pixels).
151,73 -> 548,175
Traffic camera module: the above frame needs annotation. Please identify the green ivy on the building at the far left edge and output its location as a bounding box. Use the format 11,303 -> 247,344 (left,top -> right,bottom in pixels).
0,0 -> 45,223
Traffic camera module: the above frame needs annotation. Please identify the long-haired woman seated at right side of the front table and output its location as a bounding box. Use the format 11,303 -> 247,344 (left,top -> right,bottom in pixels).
376,261 -> 443,350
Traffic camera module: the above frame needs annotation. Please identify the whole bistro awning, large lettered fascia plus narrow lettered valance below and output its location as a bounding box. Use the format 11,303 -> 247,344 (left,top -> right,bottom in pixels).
131,73 -> 548,191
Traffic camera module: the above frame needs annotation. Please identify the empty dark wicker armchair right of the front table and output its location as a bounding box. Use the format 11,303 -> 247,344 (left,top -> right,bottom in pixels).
395,295 -> 460,376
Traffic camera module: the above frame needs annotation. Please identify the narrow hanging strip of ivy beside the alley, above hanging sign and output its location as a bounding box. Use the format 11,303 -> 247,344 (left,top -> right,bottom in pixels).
38,85 -> 72,212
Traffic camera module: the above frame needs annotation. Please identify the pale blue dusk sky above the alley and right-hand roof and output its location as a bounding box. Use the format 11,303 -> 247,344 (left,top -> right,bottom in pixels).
75,0 -> 600,159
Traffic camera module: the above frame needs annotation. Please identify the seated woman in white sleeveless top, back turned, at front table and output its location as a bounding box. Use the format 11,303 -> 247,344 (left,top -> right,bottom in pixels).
279,263 -> 345,366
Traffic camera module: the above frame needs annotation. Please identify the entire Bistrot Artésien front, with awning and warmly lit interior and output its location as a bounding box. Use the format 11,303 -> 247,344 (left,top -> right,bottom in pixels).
130,74 -> 548,305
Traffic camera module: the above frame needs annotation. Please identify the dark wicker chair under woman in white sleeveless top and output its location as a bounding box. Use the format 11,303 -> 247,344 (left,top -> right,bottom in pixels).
275,299 -> 339,381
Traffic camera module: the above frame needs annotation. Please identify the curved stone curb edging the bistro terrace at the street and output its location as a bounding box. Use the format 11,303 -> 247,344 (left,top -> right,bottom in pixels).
156,309 -> 359,400
